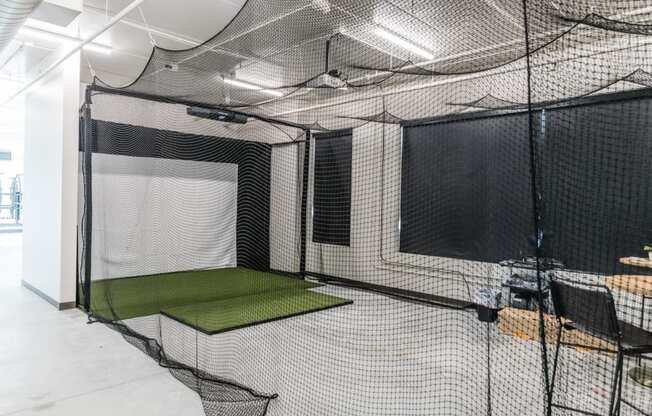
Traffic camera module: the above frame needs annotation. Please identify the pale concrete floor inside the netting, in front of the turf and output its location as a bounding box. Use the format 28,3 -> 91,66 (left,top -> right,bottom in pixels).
125,286 -> 652,416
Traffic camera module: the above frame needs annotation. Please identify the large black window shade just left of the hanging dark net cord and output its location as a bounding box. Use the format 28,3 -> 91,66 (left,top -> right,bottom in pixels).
400,114 -> 538,262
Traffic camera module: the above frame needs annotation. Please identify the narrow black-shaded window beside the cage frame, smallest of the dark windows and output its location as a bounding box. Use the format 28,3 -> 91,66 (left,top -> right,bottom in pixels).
312,130 -> 353,246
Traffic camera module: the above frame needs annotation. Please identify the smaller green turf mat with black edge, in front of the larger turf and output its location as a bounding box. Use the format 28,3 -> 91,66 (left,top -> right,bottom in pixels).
161,288 -> 352,335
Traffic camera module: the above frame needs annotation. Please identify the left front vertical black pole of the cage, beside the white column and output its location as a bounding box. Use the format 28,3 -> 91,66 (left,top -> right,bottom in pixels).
82,86 -> 93,312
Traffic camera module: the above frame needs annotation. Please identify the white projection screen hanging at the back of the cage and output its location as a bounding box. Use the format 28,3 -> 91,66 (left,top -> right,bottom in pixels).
91,154 -> 238,280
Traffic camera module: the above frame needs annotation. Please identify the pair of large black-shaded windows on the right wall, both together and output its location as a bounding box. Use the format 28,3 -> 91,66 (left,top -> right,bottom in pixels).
400,95 -> 652,274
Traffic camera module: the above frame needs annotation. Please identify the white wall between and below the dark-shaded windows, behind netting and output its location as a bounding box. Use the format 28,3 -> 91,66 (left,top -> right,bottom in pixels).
306,123 -> 486,299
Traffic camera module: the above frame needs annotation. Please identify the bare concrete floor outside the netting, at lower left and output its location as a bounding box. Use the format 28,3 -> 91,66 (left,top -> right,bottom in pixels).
0,233 -> 204,416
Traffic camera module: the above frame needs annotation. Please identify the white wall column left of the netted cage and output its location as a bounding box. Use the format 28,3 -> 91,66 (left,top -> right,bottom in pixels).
23,54 -> 80,306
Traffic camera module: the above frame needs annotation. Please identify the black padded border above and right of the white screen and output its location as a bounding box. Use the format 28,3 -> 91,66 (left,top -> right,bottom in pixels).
88,120 -> 272,270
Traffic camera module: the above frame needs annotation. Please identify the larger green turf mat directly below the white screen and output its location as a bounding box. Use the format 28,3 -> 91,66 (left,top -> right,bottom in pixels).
91,267 -> 319,320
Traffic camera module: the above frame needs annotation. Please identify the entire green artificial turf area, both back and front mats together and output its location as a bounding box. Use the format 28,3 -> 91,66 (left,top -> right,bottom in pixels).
91,268 -> 351,334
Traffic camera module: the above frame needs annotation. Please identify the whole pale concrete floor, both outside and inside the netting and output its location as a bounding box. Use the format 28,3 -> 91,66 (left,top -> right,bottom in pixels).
0,233 -> 652,416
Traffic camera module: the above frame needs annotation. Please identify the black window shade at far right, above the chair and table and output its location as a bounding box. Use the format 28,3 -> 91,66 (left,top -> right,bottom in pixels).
539,98 -> 652,274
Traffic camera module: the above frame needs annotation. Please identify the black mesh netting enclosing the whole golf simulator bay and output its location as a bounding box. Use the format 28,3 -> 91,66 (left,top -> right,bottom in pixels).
79,0 -> 652,416
